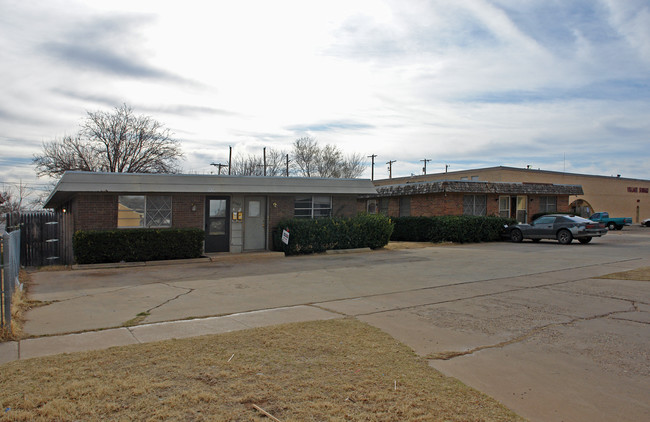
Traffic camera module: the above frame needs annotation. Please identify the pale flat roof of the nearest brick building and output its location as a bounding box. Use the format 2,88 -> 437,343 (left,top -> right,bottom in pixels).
43,171 -> 377,208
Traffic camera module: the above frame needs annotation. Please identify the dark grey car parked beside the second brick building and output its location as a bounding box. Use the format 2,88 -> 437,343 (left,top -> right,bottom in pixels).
505,214 -> 607,245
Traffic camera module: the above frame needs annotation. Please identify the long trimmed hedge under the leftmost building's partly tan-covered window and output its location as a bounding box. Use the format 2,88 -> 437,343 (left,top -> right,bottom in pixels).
72,229 -> 205,264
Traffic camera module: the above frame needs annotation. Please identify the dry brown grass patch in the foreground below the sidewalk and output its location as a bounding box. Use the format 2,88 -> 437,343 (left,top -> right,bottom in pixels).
0,319 -> 521,421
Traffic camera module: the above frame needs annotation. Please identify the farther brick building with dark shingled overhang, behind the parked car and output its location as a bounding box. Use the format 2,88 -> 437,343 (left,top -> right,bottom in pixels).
359,180 -> 583,222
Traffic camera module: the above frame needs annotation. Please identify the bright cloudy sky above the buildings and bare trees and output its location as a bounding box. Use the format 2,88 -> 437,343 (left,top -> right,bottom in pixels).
0,0 -> 650,196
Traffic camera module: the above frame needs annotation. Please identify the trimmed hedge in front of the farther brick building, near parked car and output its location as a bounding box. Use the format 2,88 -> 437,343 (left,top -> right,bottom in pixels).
390,215 -> 516,243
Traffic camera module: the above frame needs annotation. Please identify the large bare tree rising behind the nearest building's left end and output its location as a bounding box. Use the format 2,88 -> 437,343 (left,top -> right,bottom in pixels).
33,104 -> 183,176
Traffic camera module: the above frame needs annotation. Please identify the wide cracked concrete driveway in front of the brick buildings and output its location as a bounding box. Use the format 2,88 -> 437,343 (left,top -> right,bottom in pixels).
25,228 -> 650,421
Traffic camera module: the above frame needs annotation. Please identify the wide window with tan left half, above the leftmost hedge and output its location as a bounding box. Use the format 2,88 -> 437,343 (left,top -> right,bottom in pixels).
117,195 -> 172,228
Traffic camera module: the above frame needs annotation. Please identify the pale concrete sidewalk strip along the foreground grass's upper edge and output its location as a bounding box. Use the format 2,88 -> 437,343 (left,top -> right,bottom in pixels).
0,306 -> 343,364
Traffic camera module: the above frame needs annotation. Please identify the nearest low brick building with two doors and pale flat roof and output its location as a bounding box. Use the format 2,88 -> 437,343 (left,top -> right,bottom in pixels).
44,172 -> 376,253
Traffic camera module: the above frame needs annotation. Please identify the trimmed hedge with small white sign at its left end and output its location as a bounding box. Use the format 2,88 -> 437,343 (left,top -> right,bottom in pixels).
273,214 -> 393,255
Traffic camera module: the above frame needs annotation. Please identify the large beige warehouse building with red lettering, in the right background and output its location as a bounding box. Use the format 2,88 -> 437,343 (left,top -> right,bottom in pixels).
374,166 -> 650,223
